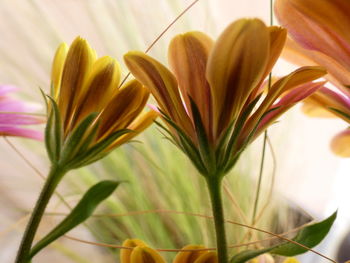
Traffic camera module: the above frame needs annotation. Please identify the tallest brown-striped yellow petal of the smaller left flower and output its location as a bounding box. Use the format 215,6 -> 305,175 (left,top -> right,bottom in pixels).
58,37 -> 95,132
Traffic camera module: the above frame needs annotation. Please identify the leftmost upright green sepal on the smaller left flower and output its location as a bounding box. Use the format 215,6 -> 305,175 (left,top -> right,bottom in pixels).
45,95 -> 63,163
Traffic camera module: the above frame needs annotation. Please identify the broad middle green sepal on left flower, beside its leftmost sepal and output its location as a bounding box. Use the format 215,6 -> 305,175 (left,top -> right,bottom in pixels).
60,112 -> 97,164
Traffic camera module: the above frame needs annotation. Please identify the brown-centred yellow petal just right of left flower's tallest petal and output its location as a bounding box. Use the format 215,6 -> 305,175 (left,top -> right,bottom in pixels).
75,56 -> 120,126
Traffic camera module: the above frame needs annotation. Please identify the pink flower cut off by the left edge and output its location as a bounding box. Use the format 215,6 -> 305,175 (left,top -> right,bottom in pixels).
0,85 -> 43,140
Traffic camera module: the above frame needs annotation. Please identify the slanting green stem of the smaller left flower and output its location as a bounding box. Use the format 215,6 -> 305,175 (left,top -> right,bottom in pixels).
15,165 -> 66,263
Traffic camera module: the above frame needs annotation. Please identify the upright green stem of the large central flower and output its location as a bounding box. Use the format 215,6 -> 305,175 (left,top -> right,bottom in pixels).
206,175 -> 228,263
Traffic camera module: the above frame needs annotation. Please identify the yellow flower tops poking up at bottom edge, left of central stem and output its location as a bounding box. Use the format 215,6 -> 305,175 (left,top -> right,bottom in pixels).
120,239 -> 218,263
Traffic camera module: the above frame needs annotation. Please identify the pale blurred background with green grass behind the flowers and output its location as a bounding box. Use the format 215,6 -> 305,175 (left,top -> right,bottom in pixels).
0,0 -> 350,263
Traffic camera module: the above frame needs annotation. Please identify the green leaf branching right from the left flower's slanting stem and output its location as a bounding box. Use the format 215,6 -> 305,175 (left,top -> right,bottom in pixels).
28,180 -> 120,259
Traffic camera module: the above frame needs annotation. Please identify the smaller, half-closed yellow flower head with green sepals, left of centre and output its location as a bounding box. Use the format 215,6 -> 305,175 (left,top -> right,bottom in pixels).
46,37 -> 158,167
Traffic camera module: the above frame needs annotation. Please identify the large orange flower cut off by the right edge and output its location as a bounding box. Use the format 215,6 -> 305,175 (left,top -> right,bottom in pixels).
275,0 -> 350,157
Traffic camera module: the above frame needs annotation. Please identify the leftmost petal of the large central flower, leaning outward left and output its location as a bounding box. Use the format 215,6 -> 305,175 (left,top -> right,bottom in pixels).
124,51 -> 195,138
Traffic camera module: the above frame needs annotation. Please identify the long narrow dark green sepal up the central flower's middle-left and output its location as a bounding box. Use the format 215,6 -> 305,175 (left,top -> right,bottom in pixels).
188,96 -> 216,174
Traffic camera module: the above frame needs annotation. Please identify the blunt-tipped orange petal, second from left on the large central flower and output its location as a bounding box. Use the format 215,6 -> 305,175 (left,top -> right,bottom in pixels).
169,32 -> 213,139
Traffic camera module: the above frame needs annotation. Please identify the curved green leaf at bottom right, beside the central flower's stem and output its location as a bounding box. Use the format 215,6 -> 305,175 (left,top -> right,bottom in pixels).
230,212 -> 337,263
